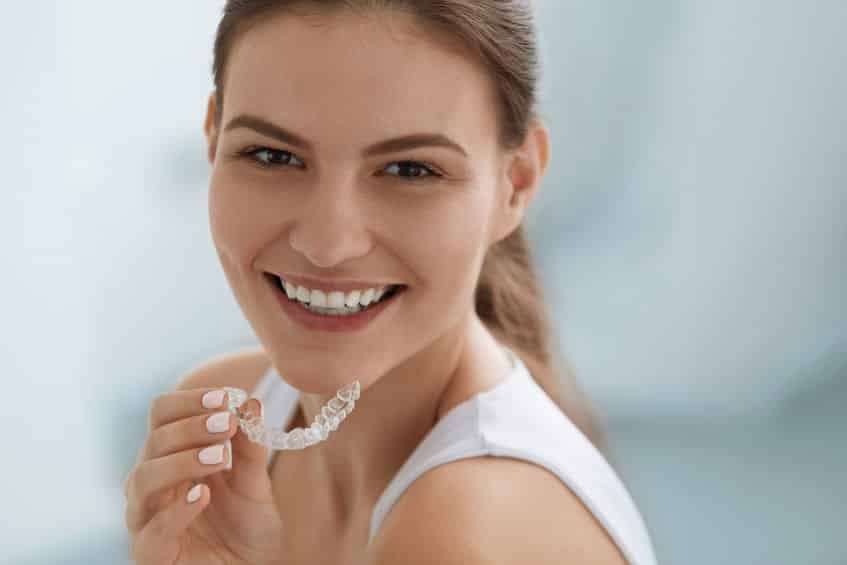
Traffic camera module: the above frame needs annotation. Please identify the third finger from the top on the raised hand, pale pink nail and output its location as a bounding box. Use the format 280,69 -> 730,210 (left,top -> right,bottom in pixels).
127,443 -> 229,531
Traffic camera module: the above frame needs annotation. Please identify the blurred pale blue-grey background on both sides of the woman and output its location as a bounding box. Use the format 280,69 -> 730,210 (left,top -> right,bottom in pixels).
0,0 -> 847,565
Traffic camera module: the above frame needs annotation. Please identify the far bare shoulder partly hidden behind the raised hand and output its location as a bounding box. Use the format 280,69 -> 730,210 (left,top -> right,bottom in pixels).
176,345 -> 271,392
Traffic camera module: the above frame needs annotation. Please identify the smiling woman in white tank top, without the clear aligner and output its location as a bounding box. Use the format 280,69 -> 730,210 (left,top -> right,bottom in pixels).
126,0 -> 654,565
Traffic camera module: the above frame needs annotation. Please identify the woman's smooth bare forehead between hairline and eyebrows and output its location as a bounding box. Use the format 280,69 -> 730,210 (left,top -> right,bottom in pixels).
223,11 -> 496,158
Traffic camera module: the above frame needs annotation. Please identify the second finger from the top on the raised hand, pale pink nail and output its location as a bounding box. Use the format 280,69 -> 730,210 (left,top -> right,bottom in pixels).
142,410 -> 238,460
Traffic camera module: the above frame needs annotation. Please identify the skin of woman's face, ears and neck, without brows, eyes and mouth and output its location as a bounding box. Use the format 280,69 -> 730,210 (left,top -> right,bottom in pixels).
205,4 -> 549,531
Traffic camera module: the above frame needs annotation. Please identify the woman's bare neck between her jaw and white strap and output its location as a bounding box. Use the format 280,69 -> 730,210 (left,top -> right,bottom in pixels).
298,312 -> 510,524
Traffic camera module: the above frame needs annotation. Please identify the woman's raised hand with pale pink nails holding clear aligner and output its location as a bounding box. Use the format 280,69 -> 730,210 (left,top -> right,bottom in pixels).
124,388 -> 282,565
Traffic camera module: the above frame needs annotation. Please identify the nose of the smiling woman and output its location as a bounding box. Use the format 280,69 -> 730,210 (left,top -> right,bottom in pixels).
288,183 -> 372,268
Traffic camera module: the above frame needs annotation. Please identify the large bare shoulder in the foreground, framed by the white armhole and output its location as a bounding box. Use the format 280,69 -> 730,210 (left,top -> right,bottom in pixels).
367,457 -> 626,565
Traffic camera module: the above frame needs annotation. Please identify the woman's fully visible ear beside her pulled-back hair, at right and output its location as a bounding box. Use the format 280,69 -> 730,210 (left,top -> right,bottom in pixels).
491,120 -> 550,243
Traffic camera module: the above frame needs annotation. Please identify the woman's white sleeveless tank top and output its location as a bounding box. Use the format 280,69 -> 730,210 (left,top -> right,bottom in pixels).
252,346 -> 656,565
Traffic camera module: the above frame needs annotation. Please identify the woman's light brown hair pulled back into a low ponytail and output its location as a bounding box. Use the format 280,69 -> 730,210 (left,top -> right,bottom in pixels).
212,0 -> 606,451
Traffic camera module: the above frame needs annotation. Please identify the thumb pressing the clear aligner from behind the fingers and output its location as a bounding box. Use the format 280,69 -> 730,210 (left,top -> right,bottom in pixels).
224,398 -> 272,500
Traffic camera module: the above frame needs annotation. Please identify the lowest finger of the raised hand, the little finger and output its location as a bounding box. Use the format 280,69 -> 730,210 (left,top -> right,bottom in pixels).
132,483 -> 211,565
